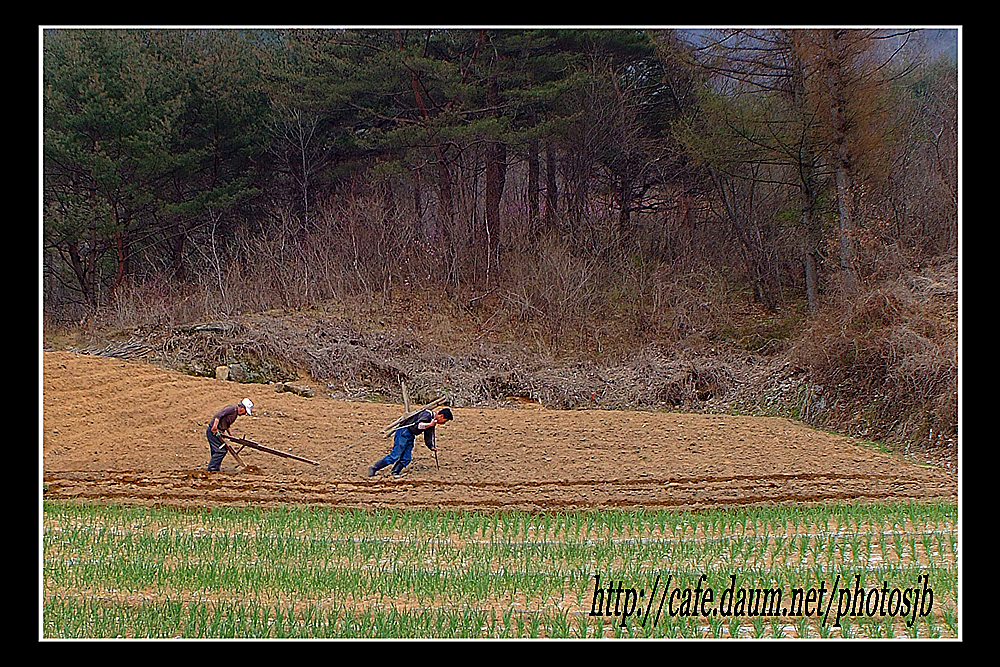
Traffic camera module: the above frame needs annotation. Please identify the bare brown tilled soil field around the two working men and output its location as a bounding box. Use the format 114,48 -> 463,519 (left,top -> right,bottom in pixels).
40,352 -> 958,510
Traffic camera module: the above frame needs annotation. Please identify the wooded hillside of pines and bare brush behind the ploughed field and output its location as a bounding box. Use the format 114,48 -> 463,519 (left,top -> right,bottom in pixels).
40,29 -> 960,462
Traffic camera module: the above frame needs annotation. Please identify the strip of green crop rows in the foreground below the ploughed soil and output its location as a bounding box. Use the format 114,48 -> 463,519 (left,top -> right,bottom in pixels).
40,502 -> 960,638
